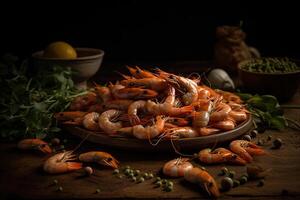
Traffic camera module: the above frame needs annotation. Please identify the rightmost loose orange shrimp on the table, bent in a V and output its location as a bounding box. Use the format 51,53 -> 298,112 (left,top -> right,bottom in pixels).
229,140 -> 266,162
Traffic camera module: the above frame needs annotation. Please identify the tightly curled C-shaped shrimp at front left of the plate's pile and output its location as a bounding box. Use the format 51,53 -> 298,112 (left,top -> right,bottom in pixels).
98,109 -> 122,134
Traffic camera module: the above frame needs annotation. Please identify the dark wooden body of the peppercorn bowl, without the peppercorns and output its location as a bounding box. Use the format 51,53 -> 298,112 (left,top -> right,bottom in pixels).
238,60 -> 300,102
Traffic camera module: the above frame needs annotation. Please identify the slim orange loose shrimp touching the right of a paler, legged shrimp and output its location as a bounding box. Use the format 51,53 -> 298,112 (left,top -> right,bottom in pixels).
79,151 -> 119,169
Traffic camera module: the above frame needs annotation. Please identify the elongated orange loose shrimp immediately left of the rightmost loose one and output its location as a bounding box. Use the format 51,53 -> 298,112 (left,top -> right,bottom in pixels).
198,148 -> 246,165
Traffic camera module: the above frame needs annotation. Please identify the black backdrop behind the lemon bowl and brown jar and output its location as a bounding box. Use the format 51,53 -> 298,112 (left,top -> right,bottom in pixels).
0,1 -> 300,62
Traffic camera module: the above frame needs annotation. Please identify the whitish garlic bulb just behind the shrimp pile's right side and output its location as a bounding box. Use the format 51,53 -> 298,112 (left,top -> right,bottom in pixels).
207,69 -> 235,90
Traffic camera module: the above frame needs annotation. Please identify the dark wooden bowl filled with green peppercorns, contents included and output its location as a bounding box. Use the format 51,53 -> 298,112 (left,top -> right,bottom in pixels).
238,58 -> 300,102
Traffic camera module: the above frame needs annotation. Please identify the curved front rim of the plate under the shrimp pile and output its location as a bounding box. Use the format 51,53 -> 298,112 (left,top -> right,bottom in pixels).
63,115 -> 253,152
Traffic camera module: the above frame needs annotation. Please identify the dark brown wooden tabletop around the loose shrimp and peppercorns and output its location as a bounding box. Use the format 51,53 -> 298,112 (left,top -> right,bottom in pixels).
0,61 -> 300,199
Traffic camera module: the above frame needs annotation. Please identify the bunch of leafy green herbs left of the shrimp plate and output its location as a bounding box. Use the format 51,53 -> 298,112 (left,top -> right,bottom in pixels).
0,55 -> 85,139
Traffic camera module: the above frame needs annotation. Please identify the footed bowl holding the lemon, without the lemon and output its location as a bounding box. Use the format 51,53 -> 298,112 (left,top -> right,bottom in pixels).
32,48 -> 104,88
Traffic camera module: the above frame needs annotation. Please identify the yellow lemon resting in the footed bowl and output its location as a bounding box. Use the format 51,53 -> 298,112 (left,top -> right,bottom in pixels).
44,41 -> 77,59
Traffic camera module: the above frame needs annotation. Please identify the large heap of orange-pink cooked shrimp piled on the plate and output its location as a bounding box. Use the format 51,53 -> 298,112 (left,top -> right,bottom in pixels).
55,67 -> 248,139
